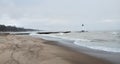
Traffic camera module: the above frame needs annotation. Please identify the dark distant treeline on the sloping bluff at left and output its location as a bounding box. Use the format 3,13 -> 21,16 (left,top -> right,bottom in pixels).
0,25 -> 36,31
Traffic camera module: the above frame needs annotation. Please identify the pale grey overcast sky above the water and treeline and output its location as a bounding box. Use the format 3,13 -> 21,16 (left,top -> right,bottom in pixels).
0,0 -> 120,30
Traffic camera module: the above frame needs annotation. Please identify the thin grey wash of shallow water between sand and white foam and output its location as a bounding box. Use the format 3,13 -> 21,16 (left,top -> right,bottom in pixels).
33,35 -> 120,64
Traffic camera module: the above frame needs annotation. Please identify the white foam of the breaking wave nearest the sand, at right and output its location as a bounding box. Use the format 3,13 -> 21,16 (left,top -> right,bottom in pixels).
74,40 -> 120,52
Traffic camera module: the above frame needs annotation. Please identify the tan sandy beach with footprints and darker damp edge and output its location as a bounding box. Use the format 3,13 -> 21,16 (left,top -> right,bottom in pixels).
0,35 -> 112,64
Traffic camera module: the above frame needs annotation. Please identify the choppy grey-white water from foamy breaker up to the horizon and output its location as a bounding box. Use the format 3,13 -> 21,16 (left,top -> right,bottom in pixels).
41,32 -> 120,53
